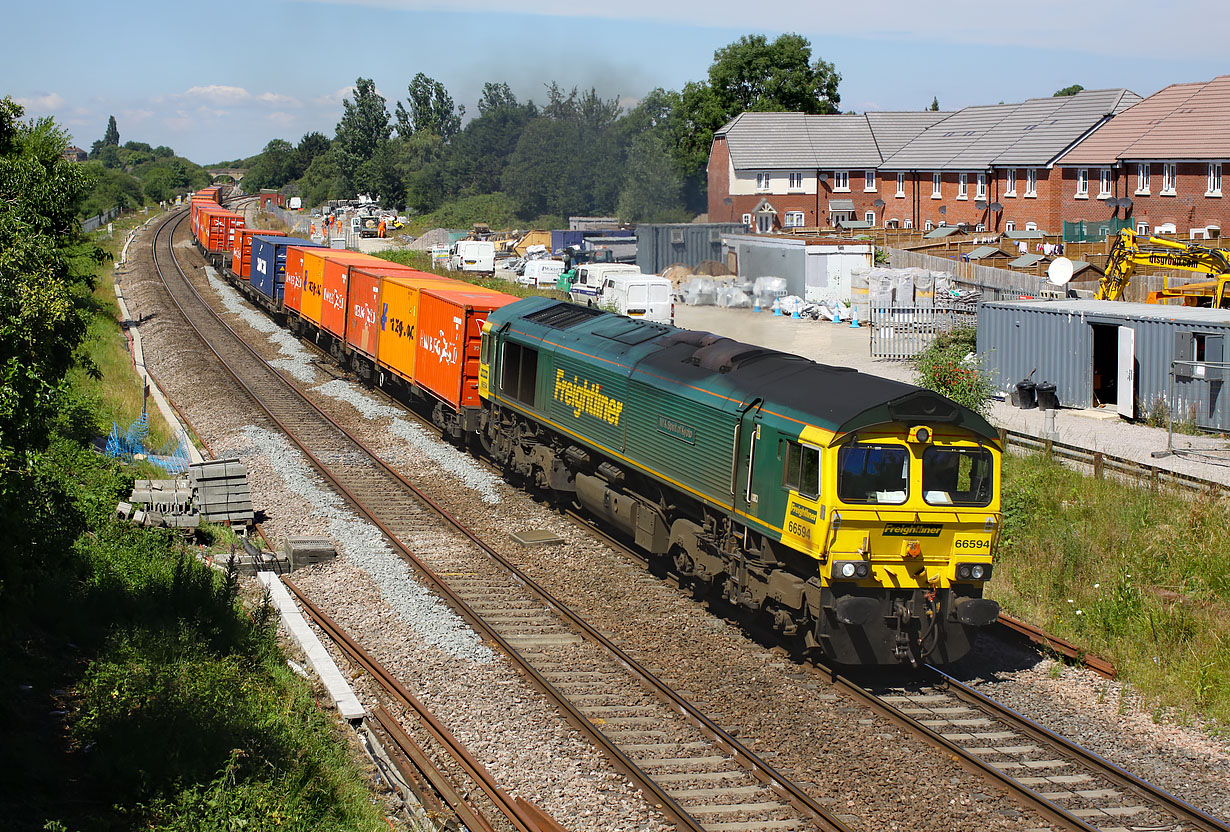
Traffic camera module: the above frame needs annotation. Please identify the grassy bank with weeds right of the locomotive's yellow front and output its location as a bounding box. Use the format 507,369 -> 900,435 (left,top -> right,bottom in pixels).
989,455 -> 1230,725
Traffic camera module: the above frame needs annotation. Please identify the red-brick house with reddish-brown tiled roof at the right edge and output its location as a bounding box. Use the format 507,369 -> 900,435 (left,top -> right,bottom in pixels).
1057,75 -> 1230,239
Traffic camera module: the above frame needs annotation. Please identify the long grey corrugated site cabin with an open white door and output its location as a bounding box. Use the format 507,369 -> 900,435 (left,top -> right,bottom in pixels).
978,299 -> 1230,431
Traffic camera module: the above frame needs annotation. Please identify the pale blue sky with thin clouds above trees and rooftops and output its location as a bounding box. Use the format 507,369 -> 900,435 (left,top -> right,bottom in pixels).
0,0 -> 1230,164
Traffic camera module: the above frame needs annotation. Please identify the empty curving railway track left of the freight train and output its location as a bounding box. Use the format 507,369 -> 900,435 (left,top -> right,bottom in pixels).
146,209 -> 849,832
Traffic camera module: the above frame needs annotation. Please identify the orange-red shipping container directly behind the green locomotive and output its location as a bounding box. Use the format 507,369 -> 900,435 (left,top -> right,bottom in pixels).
415,289 -> 518,410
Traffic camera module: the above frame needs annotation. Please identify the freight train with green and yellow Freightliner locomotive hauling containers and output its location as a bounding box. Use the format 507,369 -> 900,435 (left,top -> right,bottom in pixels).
193,188 -> 1002,666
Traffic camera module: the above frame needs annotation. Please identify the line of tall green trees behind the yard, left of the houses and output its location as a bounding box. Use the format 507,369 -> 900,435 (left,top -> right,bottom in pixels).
235,34 -> 841,224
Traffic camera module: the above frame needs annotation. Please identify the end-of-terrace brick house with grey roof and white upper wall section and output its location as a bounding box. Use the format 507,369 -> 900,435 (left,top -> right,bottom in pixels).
708,112 -> 948,233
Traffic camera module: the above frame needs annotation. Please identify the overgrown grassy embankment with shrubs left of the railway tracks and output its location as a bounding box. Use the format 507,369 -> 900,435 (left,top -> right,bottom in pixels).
0,212 -> 386,831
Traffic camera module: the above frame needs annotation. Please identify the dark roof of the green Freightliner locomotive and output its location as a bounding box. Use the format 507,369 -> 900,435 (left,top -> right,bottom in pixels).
492,298 -> 999,441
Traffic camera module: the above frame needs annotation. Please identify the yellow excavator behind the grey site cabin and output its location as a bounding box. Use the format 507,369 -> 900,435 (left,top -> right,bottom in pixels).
1093,228 -> 1230,309
